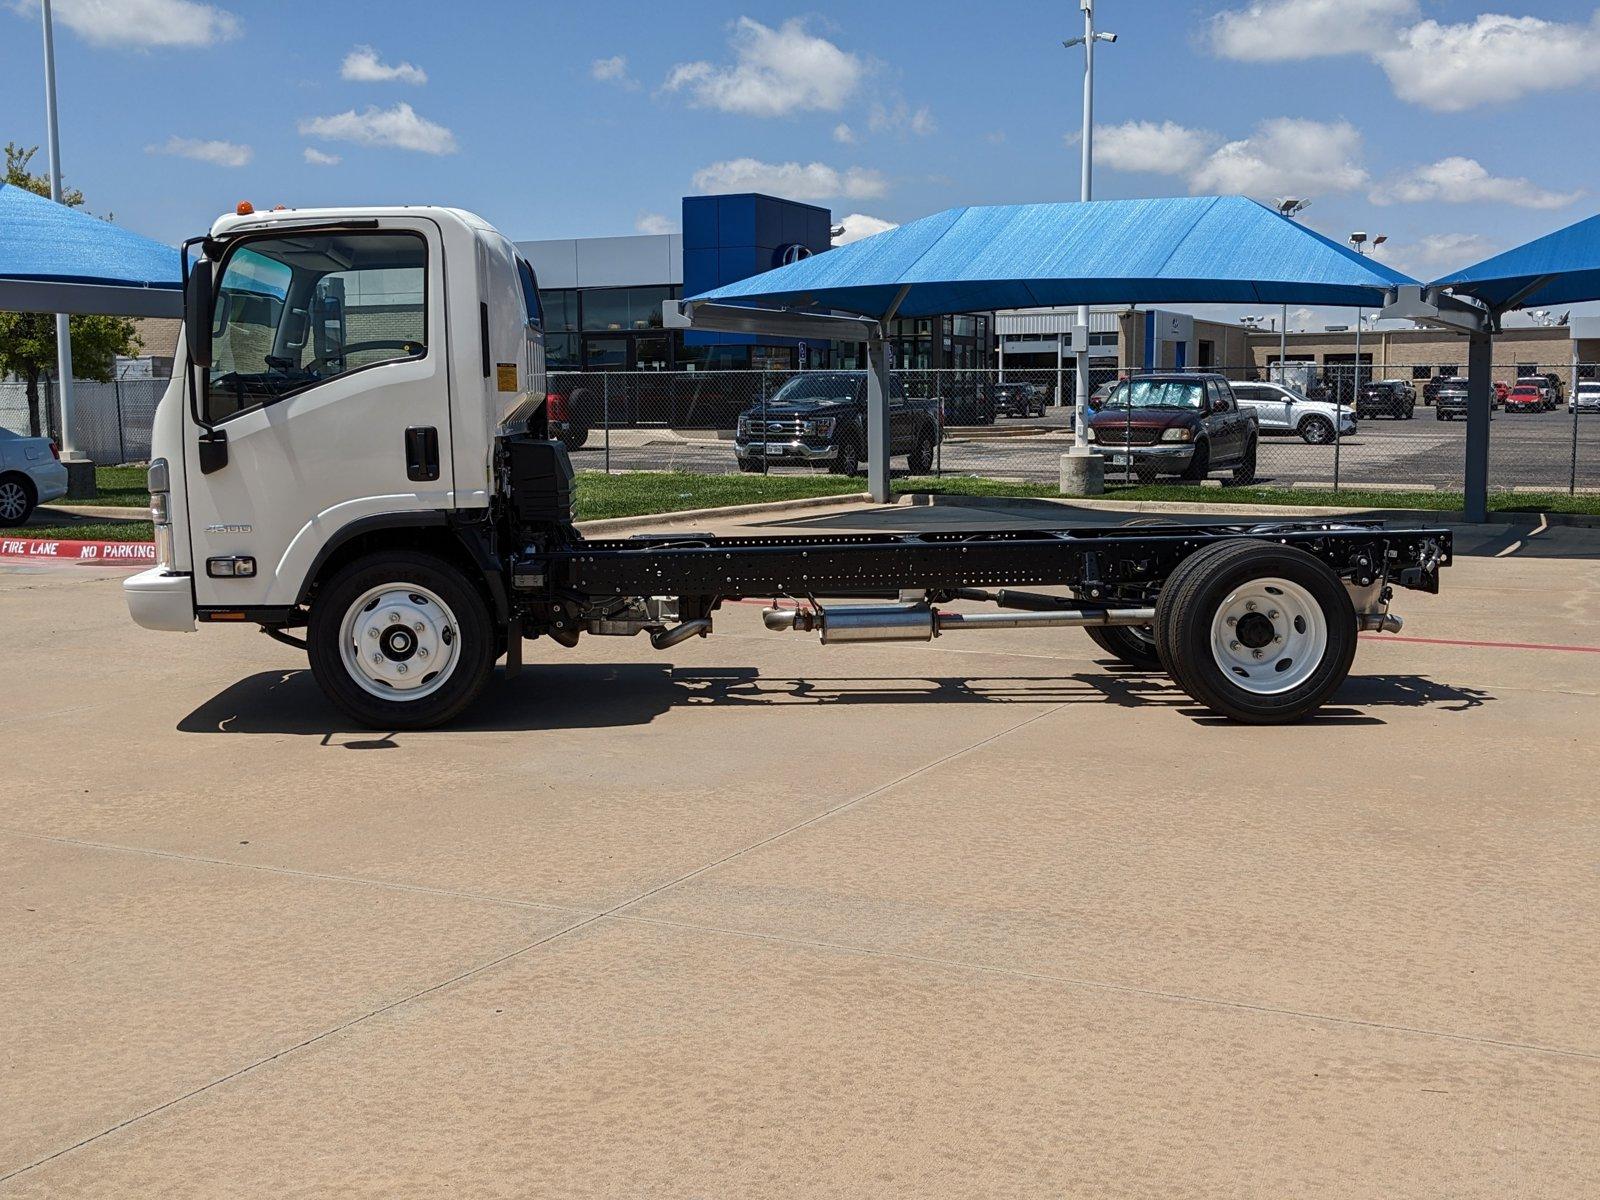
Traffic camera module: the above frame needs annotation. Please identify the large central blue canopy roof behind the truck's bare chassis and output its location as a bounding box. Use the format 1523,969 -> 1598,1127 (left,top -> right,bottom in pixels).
688,197 -> 1416,317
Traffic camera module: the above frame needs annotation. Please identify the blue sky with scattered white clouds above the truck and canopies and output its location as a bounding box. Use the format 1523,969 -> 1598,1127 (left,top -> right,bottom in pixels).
0,0 -> 1600,324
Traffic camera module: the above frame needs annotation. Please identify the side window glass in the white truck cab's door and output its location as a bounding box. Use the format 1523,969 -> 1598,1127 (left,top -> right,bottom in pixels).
206,232 -> 427,421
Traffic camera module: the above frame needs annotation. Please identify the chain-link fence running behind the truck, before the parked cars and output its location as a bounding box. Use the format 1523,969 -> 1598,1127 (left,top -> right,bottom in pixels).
0,363 -> 1600,493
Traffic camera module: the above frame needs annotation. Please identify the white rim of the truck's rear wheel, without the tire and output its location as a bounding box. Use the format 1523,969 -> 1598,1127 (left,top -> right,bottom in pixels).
1211,578 -> 1328,696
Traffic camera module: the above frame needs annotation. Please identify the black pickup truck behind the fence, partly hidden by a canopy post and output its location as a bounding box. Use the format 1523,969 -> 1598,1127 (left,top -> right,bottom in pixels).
733,371 -> 939,475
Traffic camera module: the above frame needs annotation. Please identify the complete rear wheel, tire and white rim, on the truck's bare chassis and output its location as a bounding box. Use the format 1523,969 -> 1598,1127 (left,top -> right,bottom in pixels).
1155,539 -> 1355,725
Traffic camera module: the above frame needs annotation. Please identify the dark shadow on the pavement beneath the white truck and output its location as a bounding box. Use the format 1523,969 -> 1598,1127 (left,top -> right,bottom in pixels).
178,662 -> 1494,749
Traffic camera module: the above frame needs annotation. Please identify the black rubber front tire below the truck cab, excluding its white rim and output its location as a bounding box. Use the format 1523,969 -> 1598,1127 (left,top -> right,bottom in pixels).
306,550 -> 498,730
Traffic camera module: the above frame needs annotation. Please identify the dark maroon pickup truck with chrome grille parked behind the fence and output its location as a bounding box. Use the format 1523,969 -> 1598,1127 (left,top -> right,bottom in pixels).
1088,371 -> 1261,483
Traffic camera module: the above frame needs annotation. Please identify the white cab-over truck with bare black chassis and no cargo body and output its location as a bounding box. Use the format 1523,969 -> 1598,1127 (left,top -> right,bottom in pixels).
125,205 -> 1451,728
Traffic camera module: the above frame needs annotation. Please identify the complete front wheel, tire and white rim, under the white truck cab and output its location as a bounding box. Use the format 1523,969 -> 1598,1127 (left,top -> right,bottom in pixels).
306,552 -> 496,730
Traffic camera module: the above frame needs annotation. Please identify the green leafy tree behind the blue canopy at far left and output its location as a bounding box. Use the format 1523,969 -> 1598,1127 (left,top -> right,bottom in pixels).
0,142 -> 144,437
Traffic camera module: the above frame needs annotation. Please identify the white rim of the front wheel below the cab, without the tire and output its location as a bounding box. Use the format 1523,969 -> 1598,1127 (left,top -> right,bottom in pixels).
339,582 -> 461,701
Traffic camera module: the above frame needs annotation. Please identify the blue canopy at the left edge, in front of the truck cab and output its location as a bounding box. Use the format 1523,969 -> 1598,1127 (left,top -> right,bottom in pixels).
0,184 -> 182,317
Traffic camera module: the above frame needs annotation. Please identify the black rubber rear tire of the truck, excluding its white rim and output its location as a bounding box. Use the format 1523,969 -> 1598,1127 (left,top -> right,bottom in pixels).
1155,539 -> 1355,725
